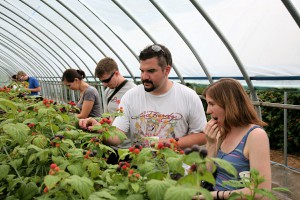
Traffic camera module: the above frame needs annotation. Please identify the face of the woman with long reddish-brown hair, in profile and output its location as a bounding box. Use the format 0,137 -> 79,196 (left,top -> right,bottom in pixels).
206,95 -> 225,126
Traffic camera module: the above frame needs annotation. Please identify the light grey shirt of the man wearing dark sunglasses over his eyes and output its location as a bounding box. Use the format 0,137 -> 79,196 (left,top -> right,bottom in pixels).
104,81 -> 136,113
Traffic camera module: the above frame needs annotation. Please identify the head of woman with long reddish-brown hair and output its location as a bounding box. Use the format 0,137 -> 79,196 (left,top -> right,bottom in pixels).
203,78 -> 266,133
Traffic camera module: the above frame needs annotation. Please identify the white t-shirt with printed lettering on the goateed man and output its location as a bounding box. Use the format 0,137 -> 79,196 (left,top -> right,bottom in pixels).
113,82 -> 207,148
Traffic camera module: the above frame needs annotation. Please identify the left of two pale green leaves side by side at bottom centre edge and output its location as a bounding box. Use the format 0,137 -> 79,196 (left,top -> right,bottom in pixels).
146,180 -> 175,200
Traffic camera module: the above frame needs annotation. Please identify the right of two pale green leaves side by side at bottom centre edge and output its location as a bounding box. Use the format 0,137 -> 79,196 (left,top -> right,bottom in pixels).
164,186 -> 199,200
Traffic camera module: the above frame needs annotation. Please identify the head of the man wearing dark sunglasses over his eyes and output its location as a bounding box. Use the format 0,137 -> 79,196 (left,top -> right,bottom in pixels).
95,57 -> 124,89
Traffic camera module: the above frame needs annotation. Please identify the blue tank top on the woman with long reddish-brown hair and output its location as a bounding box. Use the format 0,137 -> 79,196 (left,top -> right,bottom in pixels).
214,125 -> 261,191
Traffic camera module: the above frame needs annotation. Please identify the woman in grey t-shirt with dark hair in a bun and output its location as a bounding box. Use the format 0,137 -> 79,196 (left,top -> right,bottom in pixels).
62,69 -> 102,119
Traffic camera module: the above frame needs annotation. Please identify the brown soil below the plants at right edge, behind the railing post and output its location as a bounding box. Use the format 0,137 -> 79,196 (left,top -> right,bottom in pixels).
270,150 -> 300,170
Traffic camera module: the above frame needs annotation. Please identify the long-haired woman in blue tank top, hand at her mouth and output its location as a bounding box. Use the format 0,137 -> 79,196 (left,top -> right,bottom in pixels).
200,78 -> 271,199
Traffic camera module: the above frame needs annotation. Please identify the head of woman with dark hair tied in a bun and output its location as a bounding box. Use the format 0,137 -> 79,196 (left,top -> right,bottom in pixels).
61,69 -> 85,90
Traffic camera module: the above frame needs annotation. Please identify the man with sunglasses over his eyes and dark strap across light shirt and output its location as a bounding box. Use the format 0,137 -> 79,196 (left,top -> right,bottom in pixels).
95,57 -> 136,113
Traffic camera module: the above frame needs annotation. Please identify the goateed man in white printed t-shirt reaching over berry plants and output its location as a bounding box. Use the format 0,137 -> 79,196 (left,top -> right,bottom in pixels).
79,44 -> 207,152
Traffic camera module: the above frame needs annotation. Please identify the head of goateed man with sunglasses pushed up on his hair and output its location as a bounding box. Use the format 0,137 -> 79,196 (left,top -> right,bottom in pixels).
139,44 -> 172,92
